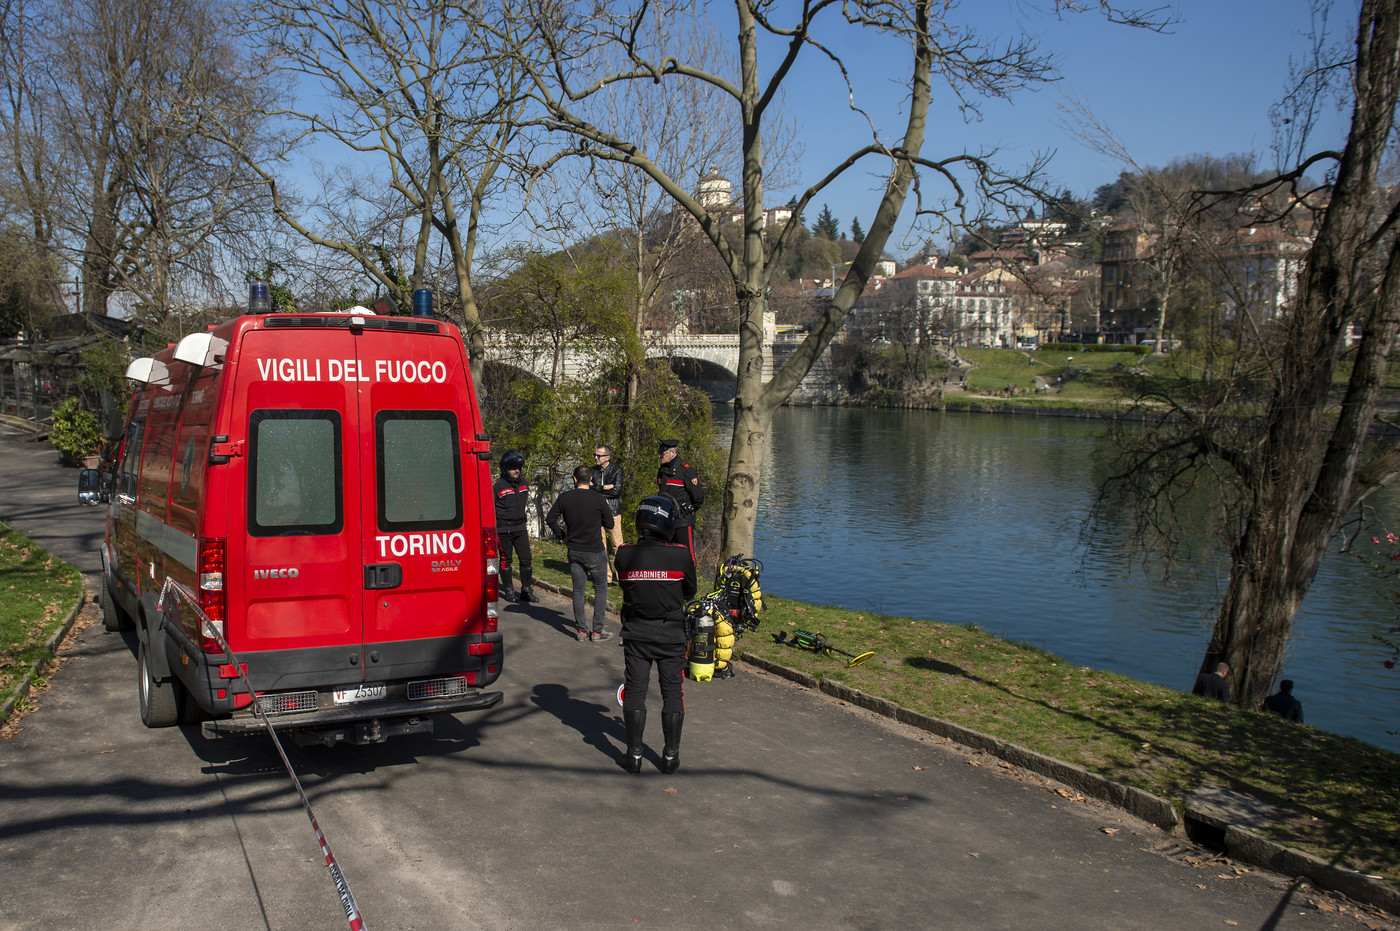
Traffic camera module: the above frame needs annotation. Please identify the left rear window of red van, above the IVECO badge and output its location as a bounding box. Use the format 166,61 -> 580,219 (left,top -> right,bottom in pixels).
248,410 -> 344,536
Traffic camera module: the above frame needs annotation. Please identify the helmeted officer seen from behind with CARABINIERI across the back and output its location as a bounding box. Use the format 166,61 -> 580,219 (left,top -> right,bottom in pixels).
617,494 -> 696,773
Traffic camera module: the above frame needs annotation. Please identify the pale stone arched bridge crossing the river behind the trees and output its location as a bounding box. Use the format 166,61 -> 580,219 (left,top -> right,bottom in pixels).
486,314 -> 840,405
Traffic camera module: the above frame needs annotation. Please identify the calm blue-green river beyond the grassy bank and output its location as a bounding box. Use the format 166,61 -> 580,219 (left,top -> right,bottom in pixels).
715,405 -> 1400,752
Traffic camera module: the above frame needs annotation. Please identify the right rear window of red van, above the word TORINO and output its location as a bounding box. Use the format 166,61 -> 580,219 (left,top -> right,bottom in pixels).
374,410 -> 462,531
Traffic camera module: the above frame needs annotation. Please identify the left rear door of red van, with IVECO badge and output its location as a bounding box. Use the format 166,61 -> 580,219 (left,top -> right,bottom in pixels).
227,323 -> 364,690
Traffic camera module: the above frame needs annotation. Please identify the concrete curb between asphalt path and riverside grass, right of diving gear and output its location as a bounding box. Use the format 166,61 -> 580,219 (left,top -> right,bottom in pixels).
735,655 -> 1400,914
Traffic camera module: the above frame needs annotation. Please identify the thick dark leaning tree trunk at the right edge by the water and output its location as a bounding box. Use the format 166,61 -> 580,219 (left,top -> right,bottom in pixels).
1201,0 -> 1400,708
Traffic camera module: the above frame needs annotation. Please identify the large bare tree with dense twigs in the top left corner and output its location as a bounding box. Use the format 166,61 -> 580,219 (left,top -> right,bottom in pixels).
3,0 -> 278,319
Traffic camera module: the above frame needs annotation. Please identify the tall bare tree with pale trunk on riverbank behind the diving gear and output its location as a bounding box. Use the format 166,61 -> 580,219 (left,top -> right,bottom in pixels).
497,0 -> 1159,556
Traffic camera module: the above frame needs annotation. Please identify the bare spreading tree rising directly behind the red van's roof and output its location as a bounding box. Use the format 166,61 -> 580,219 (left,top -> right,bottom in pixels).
245,0 -> 519,379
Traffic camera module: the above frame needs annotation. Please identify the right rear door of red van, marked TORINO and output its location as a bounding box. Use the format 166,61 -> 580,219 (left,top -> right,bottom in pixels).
357,318 -> 486,680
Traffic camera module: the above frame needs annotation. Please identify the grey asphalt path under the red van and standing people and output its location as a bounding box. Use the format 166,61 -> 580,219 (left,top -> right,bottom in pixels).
0,426 -> 1376,931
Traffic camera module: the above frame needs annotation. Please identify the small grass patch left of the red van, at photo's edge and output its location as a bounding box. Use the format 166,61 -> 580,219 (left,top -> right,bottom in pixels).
0,524 -> 83,704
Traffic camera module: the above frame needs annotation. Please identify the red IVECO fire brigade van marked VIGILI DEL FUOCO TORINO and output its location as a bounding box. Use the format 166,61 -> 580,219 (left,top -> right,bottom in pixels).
87,293 -> 503,745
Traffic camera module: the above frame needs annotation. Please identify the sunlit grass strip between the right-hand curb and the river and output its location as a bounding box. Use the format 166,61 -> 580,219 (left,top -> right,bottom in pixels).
532,540 -> 1400,883
